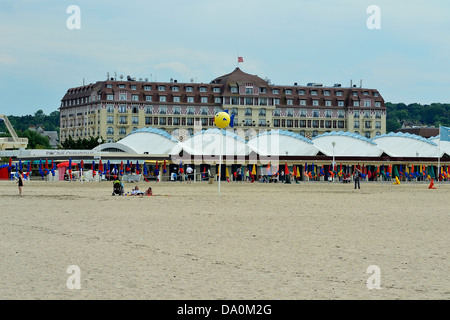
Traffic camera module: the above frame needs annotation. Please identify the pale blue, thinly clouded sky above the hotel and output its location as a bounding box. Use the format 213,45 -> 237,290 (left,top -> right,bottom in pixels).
0,0 -> 450,115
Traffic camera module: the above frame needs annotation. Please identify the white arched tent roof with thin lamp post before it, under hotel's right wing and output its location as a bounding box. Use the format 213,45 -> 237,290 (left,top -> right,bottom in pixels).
312,131 -> 383,157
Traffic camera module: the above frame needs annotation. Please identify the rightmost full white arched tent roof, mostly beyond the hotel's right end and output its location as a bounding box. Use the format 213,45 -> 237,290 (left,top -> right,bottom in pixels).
373,132 -> 438,158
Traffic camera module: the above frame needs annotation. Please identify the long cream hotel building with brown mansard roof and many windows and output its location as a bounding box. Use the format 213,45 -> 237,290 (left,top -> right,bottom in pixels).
59,68 -> 386,142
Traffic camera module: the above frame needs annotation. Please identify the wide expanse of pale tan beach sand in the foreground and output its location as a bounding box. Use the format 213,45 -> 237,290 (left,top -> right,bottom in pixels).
0,181 -> 450,300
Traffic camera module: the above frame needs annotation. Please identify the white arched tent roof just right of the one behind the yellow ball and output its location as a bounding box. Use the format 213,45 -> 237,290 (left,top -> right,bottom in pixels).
248,130 -> 319,156
